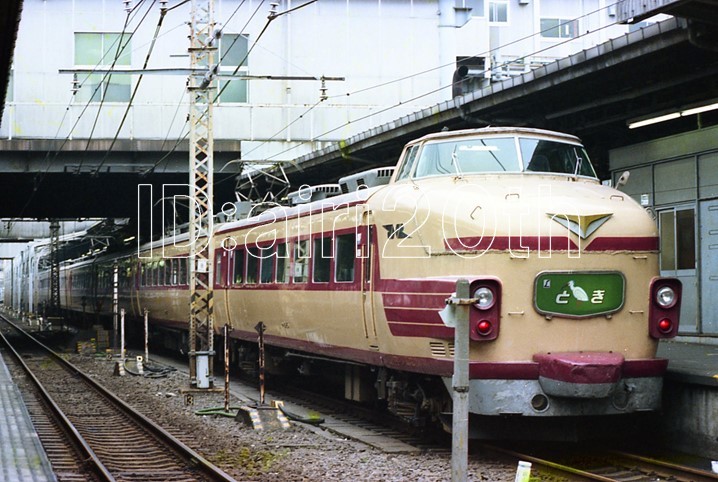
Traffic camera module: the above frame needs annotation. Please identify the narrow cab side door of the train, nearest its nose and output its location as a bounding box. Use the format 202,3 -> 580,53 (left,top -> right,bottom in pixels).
357,211 -> 378,342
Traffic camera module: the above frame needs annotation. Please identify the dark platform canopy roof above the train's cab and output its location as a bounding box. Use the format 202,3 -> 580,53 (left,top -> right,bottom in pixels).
246,17 -> 718,194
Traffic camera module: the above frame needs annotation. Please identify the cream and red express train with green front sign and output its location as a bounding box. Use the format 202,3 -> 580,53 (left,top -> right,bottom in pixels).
42,128 -> 681,436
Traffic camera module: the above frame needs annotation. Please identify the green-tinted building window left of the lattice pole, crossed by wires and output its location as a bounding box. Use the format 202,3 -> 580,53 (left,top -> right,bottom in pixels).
75,33 -> 132,102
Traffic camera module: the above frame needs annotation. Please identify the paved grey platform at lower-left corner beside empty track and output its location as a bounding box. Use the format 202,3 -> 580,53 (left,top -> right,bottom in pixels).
0,354 -> 57,482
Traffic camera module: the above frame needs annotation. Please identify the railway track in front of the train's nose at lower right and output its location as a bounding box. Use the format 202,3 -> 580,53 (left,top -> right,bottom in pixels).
482,444 -> 718,482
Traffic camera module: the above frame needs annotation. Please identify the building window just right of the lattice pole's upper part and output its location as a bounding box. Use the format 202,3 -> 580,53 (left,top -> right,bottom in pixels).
218,33 -> 249,103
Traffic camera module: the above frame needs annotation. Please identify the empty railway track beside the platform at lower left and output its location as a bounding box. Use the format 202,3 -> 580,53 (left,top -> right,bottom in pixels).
0,316 -> 234,482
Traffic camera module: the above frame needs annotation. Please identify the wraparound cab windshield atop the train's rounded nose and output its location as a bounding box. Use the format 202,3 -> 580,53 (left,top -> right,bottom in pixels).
408,136 -> 596,179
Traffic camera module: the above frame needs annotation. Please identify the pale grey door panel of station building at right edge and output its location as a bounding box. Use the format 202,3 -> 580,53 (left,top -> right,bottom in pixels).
699,199 -> 718,335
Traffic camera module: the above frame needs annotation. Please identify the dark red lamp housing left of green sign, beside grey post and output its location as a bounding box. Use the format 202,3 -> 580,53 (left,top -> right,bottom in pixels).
469,278 -> 501,341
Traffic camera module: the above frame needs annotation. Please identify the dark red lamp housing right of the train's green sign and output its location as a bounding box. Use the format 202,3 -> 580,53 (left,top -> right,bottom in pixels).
648,278 -> 682,339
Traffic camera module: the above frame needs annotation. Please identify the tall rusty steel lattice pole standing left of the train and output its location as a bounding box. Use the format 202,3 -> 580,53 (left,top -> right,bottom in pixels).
188,0 -> 217,388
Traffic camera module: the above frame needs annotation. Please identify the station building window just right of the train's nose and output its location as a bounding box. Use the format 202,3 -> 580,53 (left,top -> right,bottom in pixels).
658,207 -> 696,271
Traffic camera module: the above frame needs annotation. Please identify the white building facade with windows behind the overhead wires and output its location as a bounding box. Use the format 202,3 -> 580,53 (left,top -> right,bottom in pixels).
0,0 -> 640,164
